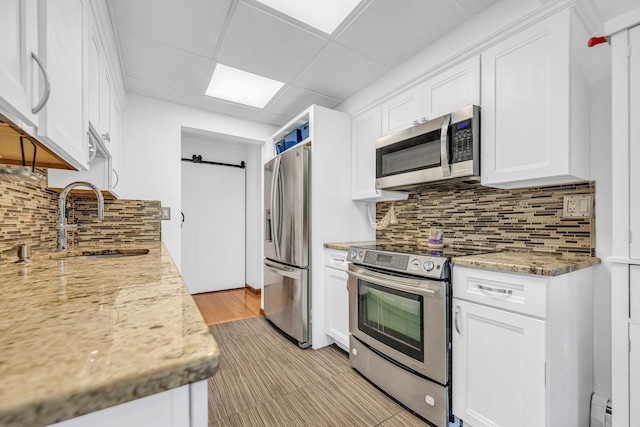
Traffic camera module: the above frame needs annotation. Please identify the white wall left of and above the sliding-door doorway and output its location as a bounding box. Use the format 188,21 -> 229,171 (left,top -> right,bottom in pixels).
120,93 -> 276,268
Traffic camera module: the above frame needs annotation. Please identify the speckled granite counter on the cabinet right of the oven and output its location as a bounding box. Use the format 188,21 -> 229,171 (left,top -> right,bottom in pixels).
451,251 -> 600,276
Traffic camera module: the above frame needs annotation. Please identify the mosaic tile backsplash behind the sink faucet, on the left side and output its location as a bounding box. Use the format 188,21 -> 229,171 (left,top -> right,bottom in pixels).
0,169 -> 161,262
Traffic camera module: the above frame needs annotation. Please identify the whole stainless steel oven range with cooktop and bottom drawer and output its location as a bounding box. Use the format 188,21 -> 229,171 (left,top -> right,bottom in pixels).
348,244 -> 482,427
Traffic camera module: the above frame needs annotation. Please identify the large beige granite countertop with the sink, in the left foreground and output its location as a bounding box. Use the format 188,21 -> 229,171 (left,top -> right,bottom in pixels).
0,243 -> 220,426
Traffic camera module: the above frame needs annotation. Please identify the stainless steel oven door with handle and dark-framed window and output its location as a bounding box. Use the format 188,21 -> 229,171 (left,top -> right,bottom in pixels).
348,263 -> 448,385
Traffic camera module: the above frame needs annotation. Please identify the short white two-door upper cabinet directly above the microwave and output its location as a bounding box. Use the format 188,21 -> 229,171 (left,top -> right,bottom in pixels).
381,56 -> 480,135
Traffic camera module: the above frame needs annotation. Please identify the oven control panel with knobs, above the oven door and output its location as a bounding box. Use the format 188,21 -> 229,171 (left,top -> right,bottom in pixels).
348,247 -> 448,279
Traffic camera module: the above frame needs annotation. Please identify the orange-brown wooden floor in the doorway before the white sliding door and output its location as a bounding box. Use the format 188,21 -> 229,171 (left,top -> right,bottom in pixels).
193,288 -> 260,325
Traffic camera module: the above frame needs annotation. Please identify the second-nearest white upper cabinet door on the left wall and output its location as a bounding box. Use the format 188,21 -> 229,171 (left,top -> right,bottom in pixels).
38,0 -> 88,170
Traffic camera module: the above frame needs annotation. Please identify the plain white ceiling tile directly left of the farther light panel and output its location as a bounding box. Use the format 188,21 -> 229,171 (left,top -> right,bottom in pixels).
120,29 -> 211,95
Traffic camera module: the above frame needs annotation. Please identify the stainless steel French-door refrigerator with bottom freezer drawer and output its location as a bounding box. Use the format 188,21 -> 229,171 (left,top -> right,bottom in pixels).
263,145 -> 311,348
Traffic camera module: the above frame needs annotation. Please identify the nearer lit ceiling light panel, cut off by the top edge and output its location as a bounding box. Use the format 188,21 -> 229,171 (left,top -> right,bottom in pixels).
258,0 -> 360,34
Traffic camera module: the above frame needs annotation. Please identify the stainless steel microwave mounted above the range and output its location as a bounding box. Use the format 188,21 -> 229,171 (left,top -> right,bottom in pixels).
376,105 -> 480,190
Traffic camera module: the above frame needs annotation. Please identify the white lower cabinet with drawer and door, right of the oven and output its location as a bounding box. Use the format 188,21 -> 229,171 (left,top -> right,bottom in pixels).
452,265 -> 593,427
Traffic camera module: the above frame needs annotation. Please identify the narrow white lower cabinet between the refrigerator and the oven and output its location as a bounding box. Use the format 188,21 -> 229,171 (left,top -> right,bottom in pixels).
324,249 -> 349,352
